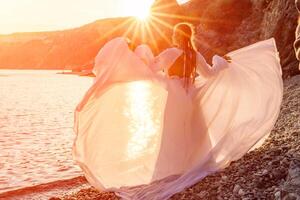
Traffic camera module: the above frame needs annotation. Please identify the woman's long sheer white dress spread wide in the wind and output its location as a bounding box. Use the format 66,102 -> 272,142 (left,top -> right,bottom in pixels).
73,38 -> 283,199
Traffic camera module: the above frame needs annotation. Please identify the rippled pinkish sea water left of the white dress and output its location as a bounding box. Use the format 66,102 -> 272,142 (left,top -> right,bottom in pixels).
0,70 -> 93,193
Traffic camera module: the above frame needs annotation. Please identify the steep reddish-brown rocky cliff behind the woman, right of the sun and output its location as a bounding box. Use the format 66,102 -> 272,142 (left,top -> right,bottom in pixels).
183,0 -> 299,77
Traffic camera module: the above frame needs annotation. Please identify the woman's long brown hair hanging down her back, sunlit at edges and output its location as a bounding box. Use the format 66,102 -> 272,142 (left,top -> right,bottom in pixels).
172,23 -> 197,88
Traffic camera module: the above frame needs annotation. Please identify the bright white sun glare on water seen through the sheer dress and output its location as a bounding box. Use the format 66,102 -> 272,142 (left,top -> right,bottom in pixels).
124,81 -> 162,159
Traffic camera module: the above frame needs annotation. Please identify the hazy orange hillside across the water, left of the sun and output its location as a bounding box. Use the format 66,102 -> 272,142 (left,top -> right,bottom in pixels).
0,18 -> 128,69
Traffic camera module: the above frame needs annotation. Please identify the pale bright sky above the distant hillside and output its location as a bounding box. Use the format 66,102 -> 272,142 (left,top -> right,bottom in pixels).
0,0 -> 159,34
